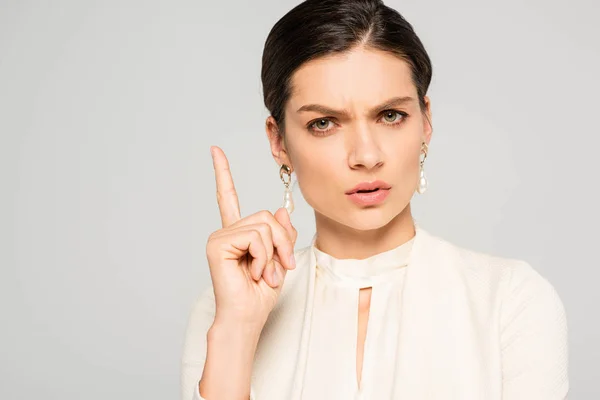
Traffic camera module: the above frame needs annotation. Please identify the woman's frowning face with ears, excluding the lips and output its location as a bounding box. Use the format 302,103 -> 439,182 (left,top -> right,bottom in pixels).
267,48 -> 431,230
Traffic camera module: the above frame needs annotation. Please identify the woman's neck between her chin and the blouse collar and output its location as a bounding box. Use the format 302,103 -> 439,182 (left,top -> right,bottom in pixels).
315,203 -> 415,259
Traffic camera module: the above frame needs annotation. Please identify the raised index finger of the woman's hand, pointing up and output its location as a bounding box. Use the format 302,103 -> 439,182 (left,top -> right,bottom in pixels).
210,146 -> 241,228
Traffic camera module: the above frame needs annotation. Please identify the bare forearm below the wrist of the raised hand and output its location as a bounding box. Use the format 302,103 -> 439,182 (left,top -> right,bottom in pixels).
199,323 -> 260,400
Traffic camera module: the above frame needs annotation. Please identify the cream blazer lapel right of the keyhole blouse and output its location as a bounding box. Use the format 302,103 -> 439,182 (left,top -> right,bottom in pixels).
393,226 -> 492,400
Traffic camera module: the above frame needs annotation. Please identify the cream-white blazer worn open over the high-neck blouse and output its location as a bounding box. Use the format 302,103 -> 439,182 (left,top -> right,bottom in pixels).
182,225 -> 569,400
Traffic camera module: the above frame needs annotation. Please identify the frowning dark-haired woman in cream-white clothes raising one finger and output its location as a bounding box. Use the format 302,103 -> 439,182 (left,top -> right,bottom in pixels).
182,0 -> 569,400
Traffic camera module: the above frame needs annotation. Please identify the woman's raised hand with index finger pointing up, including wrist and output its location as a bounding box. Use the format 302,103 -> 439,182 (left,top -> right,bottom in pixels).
206,146 -> 297,332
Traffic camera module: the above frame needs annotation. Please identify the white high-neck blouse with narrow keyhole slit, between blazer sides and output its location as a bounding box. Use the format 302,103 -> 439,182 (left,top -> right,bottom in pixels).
303,234 -> 414,399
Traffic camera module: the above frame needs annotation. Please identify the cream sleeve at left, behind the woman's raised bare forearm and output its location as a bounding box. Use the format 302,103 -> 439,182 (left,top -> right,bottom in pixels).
181,285 -> 256,400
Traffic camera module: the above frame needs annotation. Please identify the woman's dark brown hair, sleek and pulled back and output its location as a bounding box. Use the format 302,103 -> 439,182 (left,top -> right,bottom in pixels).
261,0 -> 432,134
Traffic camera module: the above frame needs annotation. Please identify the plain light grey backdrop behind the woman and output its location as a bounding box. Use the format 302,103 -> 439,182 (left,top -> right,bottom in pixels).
0,0 -> 600,400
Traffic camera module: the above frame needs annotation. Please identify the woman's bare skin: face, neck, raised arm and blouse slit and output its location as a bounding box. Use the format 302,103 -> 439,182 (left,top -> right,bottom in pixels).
200,46 -> 432,399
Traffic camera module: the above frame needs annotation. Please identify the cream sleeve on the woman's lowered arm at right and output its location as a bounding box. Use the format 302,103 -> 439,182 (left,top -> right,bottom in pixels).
501,261 -> 569,400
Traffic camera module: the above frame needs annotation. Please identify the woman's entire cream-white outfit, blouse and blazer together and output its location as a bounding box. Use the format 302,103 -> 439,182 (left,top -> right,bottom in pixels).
182,224 -> 569,400
